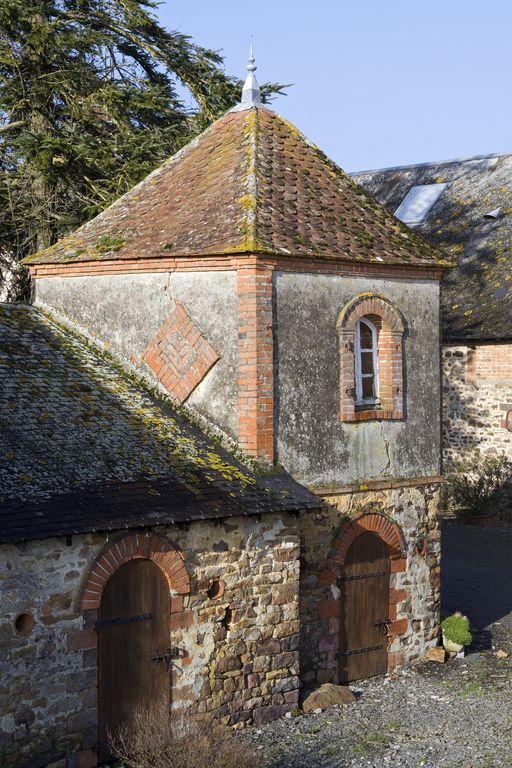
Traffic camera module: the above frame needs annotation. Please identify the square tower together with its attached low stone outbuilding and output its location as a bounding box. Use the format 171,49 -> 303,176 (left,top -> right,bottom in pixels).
0,55 -> 444,768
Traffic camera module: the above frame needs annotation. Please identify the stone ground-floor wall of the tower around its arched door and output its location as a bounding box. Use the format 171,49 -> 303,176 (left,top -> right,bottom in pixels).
301,483 -> 440,687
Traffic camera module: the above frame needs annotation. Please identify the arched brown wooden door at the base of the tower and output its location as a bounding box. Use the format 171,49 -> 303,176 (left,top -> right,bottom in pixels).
340,532 -> 389,683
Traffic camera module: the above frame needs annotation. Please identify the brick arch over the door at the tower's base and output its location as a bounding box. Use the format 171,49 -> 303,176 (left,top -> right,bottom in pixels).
331,512 -> 405,572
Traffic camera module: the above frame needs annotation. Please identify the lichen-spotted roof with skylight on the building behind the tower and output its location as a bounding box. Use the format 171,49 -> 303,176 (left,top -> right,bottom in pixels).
353,154 -> 512,341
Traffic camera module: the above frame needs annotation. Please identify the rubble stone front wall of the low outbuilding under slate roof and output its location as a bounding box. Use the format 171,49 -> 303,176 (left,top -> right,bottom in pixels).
0,514 -> 299,768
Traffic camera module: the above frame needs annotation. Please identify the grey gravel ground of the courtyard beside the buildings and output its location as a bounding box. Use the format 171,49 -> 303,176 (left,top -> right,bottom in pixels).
240,521 -> 512,768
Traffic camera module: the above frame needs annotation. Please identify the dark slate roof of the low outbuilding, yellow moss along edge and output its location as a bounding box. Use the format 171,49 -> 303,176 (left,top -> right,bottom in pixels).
0,304 -> 319,542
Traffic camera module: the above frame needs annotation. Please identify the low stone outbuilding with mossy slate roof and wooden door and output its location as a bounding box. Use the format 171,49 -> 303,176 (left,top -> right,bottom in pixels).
0,304 -> 318,768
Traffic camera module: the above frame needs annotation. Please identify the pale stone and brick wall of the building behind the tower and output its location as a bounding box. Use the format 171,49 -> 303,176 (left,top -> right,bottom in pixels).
443,343 -> 512,465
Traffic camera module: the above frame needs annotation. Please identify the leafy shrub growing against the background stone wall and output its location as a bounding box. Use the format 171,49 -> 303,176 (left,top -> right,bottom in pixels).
444,451 -> 511,525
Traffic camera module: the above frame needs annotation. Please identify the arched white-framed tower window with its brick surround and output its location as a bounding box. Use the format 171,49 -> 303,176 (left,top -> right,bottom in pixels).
337,293 -> 405,421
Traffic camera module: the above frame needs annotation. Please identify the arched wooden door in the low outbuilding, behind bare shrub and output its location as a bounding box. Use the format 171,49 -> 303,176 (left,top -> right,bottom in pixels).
97,559 -> 170,762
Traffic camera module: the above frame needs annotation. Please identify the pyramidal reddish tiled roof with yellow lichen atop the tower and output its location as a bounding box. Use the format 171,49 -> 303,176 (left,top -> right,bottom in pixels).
26,107 -> 448,265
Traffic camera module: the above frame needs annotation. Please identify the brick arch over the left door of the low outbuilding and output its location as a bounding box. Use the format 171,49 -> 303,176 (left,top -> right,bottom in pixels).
80,533 -> 190,611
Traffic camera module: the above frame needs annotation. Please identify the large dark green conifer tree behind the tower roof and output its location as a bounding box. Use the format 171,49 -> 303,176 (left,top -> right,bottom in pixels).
0,0 -> 282,258
